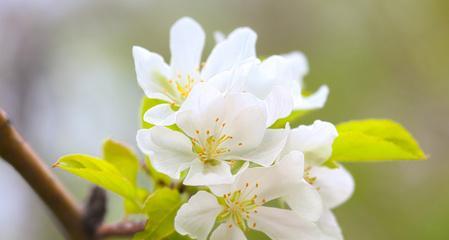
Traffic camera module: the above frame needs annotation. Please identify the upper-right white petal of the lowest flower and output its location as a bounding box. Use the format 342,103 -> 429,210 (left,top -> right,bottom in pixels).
226,152 -> 304,204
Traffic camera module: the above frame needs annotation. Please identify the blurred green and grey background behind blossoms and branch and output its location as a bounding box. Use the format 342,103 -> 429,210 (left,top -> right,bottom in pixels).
0,0 -> 449,240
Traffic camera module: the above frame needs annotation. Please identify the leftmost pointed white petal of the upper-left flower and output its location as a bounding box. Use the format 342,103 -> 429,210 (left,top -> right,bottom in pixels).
133,46 -> 172,100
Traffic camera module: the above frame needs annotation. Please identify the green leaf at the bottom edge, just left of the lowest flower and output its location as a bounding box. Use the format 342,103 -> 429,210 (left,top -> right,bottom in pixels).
134,188 -> 183,240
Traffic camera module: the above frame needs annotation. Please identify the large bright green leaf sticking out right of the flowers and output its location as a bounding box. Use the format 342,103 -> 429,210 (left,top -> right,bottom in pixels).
329,119 -> 427,162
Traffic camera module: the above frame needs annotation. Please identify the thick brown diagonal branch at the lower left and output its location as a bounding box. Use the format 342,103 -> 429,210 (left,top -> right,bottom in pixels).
0,109 -> 86,240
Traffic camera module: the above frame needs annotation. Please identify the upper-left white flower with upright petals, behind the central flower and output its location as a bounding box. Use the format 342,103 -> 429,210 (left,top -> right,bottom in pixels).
133,17 -> 257,126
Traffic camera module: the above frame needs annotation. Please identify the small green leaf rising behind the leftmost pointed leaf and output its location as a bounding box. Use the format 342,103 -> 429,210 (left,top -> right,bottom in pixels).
103,139 -> 139,184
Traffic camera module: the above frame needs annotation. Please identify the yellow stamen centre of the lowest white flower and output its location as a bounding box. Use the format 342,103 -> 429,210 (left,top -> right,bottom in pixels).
218,183 -> 266,231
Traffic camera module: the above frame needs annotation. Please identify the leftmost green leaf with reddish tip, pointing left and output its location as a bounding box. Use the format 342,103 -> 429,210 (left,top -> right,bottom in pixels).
53,154 -> 136,201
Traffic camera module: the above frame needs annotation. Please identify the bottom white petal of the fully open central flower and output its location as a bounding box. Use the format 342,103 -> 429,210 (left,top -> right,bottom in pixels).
184,160 -> 234,186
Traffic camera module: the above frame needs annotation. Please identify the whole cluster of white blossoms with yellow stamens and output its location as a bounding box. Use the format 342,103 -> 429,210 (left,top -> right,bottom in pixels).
133,18 -> 354,240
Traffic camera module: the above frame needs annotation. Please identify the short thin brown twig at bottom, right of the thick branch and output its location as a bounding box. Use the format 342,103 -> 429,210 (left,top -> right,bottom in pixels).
97,221 -> 145,239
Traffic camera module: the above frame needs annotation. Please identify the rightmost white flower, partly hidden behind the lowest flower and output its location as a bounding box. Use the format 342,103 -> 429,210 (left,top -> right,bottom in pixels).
284,120 -> 354,240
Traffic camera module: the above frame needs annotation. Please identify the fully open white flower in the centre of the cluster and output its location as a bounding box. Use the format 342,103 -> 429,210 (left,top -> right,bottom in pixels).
137,84 -> 288,185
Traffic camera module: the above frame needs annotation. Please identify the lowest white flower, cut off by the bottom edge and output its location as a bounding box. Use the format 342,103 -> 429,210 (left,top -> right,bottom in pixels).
175,152 -> 322,240
